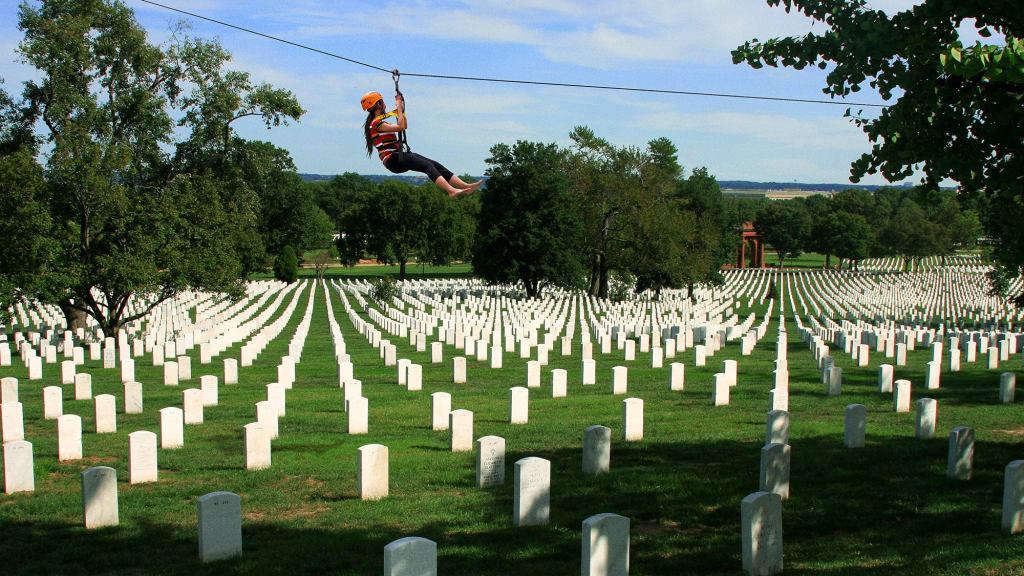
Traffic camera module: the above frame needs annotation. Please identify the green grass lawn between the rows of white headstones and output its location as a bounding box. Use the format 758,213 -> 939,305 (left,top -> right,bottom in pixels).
0,266 -> 1024,576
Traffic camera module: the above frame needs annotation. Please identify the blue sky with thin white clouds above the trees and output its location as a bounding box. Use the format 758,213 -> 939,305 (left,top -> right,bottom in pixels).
0,0 -> 987,183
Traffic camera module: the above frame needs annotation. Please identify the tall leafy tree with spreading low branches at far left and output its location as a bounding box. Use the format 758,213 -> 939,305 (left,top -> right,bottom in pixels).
9,0 -> 301,334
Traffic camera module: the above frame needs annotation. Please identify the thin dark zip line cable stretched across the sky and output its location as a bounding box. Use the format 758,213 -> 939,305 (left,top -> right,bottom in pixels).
138,0 -> 888,108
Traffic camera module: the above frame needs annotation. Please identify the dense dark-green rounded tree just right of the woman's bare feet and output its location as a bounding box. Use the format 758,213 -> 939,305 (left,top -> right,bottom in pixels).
473,140 -> 583,298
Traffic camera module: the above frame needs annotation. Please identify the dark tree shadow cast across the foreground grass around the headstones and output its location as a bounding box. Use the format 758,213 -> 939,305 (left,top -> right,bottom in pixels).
0,433 -> 1024,576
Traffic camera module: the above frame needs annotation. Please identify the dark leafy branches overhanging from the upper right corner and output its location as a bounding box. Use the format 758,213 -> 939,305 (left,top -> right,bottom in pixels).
732,0 -> 1024,303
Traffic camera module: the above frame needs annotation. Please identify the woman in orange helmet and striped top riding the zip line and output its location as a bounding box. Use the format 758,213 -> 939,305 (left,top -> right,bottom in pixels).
361,92 -> 483,197
